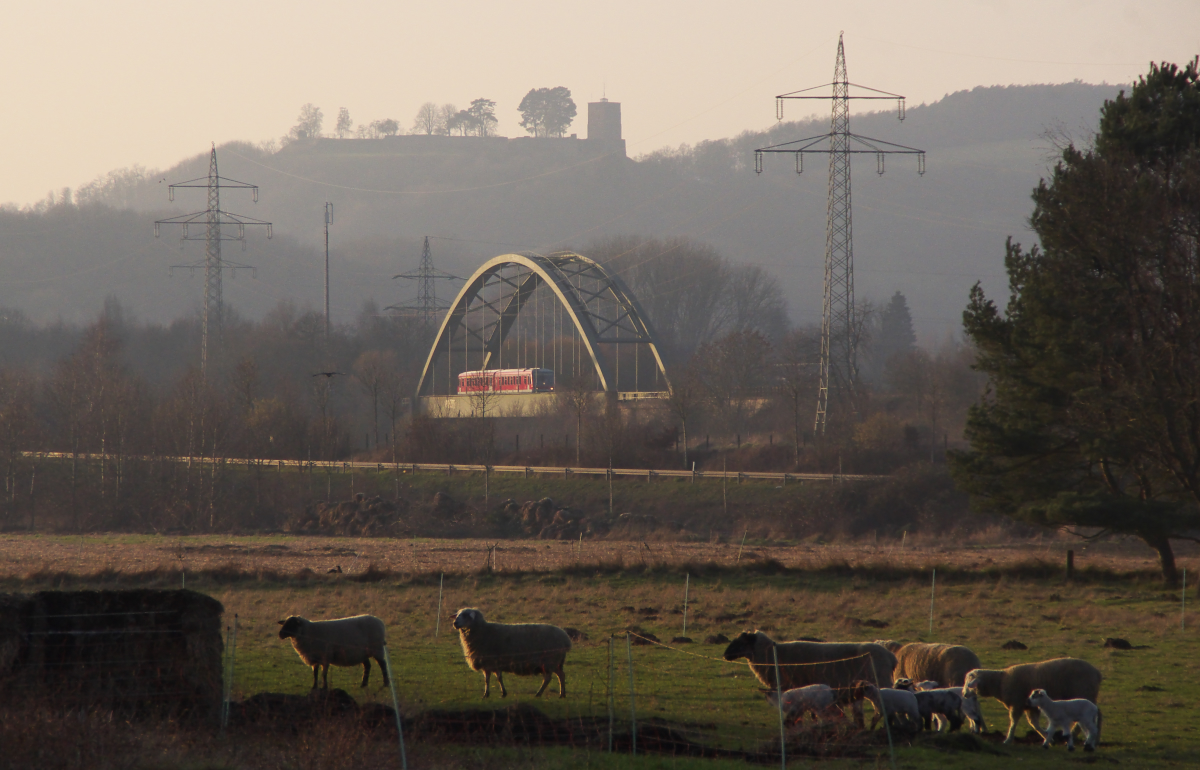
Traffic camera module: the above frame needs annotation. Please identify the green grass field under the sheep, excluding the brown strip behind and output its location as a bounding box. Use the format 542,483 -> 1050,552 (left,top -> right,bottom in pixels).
0,532 -> 1200,769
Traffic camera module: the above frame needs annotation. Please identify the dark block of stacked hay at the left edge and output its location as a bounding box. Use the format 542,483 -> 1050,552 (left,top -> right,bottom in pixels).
0,589 -> 224,718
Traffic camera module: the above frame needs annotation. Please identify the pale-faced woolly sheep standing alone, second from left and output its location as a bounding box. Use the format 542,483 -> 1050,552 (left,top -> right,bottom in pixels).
454,608 -> 571,698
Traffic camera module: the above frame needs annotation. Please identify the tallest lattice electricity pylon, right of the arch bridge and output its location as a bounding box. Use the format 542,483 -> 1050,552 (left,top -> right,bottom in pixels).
755,35 -> 925,435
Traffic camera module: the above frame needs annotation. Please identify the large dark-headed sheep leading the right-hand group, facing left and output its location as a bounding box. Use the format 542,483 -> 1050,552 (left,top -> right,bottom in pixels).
724,631 -> 895,724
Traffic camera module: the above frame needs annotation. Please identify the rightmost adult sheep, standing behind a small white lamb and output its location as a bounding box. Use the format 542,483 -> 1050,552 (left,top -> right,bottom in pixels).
962,657 -> 1103,744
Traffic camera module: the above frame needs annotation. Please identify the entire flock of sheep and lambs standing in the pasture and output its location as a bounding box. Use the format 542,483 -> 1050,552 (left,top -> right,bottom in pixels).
280,608 -> 1102,751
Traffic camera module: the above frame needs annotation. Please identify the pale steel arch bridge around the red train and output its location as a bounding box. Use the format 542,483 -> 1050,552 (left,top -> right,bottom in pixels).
415,252 -> 670,399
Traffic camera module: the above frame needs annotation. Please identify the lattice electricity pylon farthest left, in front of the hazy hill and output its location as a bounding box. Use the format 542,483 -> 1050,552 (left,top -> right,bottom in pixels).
154,143 -> 272,377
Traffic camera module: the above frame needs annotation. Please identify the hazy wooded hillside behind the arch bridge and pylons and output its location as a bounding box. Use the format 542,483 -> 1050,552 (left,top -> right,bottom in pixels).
0,83 -> 1117,341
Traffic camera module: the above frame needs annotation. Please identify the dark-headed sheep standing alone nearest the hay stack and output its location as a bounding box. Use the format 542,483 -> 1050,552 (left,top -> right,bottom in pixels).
280,615 -> 389,690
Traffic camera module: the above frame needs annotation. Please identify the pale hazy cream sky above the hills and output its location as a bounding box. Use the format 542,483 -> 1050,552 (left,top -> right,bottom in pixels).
0,0 -> 1200,204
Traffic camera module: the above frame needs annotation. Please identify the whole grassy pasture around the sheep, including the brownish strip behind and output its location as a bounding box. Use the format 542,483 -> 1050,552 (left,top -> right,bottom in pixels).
0,535 -> 1200,769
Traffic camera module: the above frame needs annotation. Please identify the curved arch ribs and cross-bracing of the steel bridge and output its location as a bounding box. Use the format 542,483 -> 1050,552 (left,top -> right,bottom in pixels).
415,252 -> 670,397
